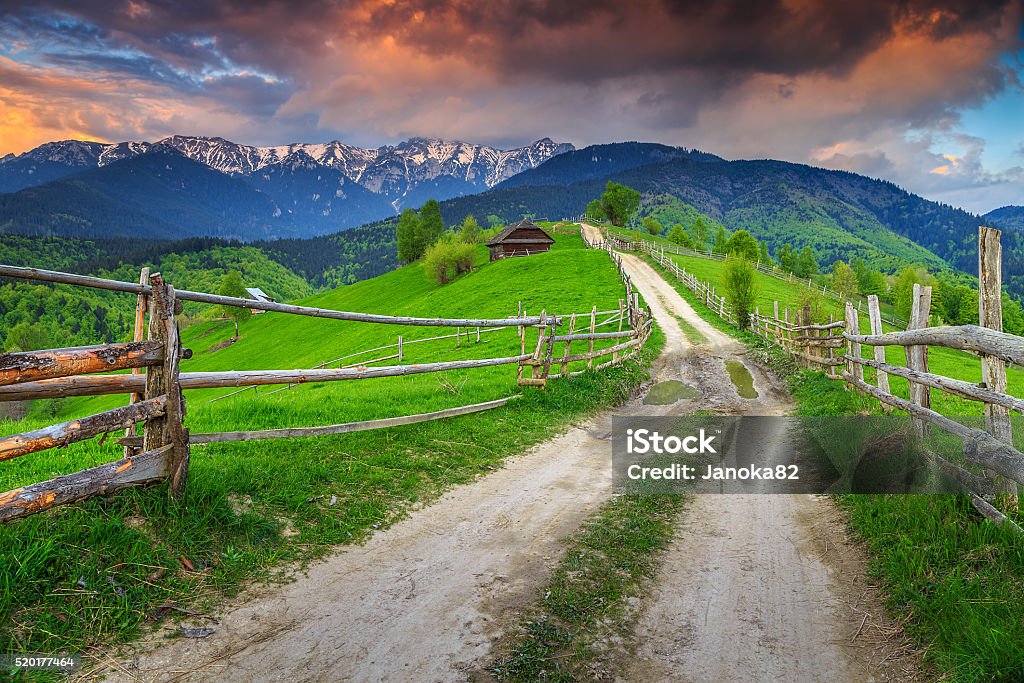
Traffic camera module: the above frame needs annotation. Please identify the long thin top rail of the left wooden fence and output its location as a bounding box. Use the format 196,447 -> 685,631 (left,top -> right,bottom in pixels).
0,265 -> 561,328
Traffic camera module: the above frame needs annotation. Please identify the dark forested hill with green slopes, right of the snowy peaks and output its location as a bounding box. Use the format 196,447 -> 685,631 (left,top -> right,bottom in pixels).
442,143 -> 1024,296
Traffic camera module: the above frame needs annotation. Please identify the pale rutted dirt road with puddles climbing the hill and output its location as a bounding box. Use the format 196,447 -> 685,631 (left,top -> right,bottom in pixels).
96,232 -> 913,683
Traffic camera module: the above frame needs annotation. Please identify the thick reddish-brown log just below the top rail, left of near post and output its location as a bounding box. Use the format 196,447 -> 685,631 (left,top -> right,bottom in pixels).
0,341 -> 164,386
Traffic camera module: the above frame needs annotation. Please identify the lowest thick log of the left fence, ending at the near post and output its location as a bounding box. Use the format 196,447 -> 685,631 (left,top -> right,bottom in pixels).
0,444 -> 171,523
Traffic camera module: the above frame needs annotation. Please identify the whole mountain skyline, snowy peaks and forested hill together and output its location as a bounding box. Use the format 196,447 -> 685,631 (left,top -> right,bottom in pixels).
0,136 -> 1024,295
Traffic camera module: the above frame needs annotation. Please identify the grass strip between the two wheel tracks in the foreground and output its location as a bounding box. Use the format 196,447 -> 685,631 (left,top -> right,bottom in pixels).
488,495 -> 685,681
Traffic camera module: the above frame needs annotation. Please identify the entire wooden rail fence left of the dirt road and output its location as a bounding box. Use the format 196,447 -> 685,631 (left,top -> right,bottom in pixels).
0,257 -> 651,522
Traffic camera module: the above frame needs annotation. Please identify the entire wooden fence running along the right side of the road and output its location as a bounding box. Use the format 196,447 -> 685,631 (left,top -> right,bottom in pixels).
598,227 -> 1024,527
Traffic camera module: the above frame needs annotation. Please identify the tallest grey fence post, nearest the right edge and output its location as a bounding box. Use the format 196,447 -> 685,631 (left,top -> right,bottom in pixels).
978,226 -> 1017,505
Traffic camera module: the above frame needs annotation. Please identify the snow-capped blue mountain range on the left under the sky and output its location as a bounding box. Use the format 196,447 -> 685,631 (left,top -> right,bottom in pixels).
0,135 -> 573,241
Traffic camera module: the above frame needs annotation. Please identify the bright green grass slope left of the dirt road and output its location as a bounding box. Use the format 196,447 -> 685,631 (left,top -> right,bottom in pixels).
0,234 -> 663,671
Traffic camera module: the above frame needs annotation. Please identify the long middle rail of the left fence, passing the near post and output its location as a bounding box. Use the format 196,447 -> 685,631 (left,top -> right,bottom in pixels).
0,352 -> 544,400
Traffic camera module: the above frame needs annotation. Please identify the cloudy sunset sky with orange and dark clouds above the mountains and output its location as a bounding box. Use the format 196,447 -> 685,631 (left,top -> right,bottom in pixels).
0,0 -> 1024,212
